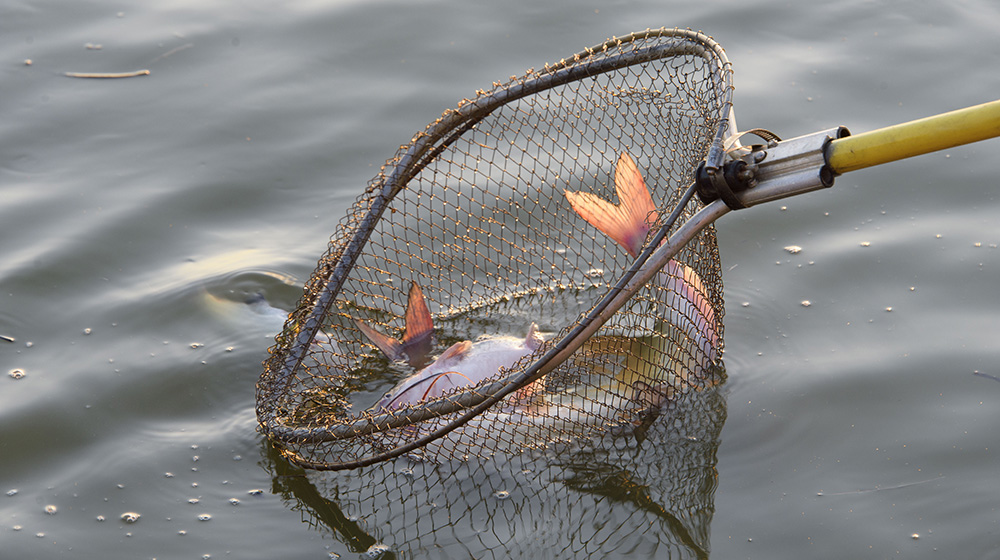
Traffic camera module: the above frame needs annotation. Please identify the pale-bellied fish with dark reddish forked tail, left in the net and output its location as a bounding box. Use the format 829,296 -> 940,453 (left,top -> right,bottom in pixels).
356,282 -> 544,411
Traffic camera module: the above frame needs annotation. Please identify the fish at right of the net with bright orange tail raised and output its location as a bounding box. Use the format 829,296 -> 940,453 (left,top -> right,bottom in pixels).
564,152 -> 721,382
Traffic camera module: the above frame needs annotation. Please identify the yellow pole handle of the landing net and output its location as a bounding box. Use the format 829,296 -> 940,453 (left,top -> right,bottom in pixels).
827,100 -> 1000,174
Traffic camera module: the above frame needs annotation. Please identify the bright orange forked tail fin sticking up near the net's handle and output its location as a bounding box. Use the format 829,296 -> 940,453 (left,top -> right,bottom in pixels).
565,152 -> 657,258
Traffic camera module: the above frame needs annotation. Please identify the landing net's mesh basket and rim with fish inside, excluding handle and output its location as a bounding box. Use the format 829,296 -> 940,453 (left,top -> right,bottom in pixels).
257,29 -> 732,470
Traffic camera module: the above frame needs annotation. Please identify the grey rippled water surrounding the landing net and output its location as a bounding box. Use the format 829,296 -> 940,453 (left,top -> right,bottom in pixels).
0,0 -> 1000,558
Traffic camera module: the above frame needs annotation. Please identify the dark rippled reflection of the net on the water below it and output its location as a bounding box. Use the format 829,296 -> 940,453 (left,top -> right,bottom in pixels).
262,378 -> 726,559
